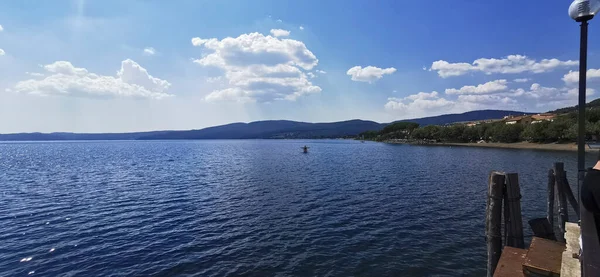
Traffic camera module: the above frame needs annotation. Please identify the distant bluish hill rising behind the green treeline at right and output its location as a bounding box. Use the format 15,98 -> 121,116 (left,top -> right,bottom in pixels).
399,110 -> 537,126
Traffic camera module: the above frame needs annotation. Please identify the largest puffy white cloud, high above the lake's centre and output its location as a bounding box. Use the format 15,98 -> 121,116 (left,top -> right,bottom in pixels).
192,33 -> 321,102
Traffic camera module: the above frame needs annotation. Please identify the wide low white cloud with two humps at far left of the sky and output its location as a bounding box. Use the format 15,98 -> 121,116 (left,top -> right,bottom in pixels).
13,59 -> 171,99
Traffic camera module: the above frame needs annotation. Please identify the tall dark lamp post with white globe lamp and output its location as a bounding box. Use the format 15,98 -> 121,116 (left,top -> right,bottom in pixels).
569,0 -> 600,276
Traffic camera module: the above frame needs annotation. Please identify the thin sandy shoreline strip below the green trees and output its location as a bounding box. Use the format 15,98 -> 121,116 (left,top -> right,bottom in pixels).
384,141 -> 594,152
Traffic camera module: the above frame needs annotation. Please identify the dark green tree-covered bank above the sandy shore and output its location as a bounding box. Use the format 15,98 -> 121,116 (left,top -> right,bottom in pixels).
360,109 -> 600,143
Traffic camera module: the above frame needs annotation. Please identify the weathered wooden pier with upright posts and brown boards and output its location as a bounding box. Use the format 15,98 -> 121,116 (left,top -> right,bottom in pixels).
485,163 -> 581,277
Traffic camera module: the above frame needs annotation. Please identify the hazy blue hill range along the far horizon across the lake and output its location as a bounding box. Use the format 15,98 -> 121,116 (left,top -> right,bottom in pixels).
0,110 -> 525,141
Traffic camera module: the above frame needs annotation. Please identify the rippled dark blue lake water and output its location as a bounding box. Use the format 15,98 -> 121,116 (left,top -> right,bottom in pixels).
0,140 -> 594,276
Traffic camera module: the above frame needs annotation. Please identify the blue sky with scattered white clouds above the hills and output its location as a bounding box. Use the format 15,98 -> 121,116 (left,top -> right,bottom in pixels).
0,0 -> 600,133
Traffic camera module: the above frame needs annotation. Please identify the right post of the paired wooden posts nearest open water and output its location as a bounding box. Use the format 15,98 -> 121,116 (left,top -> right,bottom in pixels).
504,173 -> 525,249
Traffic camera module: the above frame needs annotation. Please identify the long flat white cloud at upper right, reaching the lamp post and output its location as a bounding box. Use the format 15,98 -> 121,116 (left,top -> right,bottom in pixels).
430,55 -> 579,78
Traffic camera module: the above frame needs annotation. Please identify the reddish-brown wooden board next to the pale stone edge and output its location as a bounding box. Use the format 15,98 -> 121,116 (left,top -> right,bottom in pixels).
523,237 -> 565,276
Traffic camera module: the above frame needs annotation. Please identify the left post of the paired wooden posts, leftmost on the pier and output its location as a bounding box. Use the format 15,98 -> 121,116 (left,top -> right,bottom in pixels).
485,171 -> 504,277
